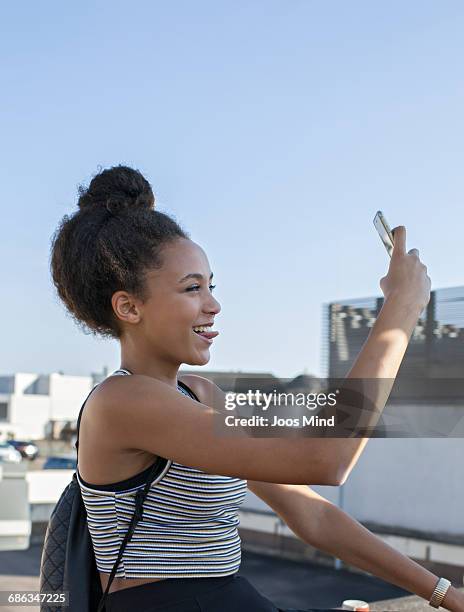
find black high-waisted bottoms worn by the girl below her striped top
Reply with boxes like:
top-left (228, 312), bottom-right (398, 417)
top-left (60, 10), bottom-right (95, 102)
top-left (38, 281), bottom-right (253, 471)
top-left (106, 574), bottom-right (326, 612)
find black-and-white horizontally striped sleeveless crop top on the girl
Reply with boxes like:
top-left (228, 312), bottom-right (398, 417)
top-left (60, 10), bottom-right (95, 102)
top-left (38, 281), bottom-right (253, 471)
top-left (76, 370), bottom-right (247, 578)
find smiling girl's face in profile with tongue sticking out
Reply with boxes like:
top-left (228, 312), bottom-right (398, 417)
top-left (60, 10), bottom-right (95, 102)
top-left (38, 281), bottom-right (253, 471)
top-left (136, 238), bottom-right (221, 365)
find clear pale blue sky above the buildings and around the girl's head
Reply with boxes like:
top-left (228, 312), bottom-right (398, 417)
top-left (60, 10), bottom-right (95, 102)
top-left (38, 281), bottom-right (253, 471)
top-left (0, 0), bottom-right (464, 376)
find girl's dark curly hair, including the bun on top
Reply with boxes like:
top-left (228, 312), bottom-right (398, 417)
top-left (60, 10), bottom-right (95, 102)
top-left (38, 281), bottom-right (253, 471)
top-left (50, 165), bottom-right (189, 338)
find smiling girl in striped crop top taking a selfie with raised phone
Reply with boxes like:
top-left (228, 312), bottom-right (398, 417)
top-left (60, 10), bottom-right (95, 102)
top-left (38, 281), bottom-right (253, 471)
top-left (51, 166), bottom-right (464, 612)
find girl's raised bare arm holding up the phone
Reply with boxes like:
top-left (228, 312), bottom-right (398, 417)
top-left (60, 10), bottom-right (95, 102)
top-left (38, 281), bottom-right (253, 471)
top-left (92, 228), bottom-right (430, 485)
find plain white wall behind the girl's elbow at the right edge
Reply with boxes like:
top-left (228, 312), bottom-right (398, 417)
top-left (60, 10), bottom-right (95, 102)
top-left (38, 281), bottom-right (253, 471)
top-left (244, 438), bottom-right (464, 539)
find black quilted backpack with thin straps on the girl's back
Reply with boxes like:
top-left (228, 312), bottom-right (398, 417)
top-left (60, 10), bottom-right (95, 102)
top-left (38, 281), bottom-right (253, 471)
top-left (40, 383), bottom-right (172, 612)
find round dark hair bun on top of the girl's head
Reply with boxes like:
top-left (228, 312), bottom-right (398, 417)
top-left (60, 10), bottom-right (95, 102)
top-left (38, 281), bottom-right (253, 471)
top-left (78, 166), bottom-right (155, 214)
